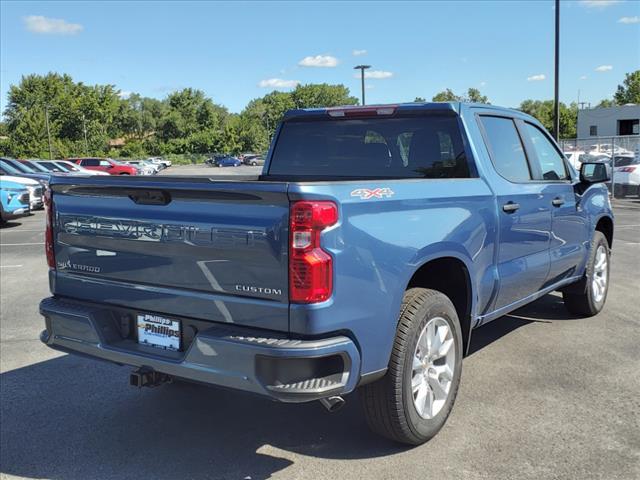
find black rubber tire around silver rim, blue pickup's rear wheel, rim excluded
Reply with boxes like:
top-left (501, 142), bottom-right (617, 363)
top-left (360, 288), bottom-right (463, 445)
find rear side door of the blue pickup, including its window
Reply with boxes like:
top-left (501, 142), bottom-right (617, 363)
top-left (478, 111), bottom-right (551, 310)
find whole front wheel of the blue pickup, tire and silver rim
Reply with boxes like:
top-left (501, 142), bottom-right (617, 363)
top-left (562, 231), bottom-right (610, 317)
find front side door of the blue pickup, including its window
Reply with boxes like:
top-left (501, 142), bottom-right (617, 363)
top-left (517, 121), bottom-right (590, 285)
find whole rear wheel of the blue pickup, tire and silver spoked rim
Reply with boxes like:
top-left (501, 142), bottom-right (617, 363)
top-left (361, 288), bottom-right (462, 445)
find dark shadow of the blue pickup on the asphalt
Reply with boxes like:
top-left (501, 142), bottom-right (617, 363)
top-left (0, 296), bottom-right (580, 480)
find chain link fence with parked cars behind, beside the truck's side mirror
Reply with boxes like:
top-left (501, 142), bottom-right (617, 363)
top-left (559, 135), bottom-right (640, 199)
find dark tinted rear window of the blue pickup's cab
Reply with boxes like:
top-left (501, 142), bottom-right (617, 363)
top-left (269, 116), bottom-right (471, 178)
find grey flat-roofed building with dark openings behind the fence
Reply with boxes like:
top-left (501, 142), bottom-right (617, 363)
top-left (578, 105), bottom-right (640, 138)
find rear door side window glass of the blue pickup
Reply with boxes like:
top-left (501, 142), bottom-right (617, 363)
top-left (480, 116), bottom-right (531, 182)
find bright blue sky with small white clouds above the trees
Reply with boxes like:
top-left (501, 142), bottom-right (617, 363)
top-left (0, 0), bottom-right (640, 112)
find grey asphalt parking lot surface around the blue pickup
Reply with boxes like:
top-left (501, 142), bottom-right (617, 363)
top-left (0, 171), bottom-right (640, 480)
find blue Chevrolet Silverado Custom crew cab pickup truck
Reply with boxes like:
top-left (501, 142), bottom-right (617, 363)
top-left (40, 103), bottom-right (613, 444)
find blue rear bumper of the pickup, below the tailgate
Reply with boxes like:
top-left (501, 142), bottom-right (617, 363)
top-left (40, 297), bottom-right (360, 402)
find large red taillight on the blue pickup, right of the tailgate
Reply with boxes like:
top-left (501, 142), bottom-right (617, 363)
top-left (289, 200), bottom-right (338, 303)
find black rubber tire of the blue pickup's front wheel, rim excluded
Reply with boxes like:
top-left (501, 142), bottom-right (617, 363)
top-left (562, 231), bottom-right (611, 317)
